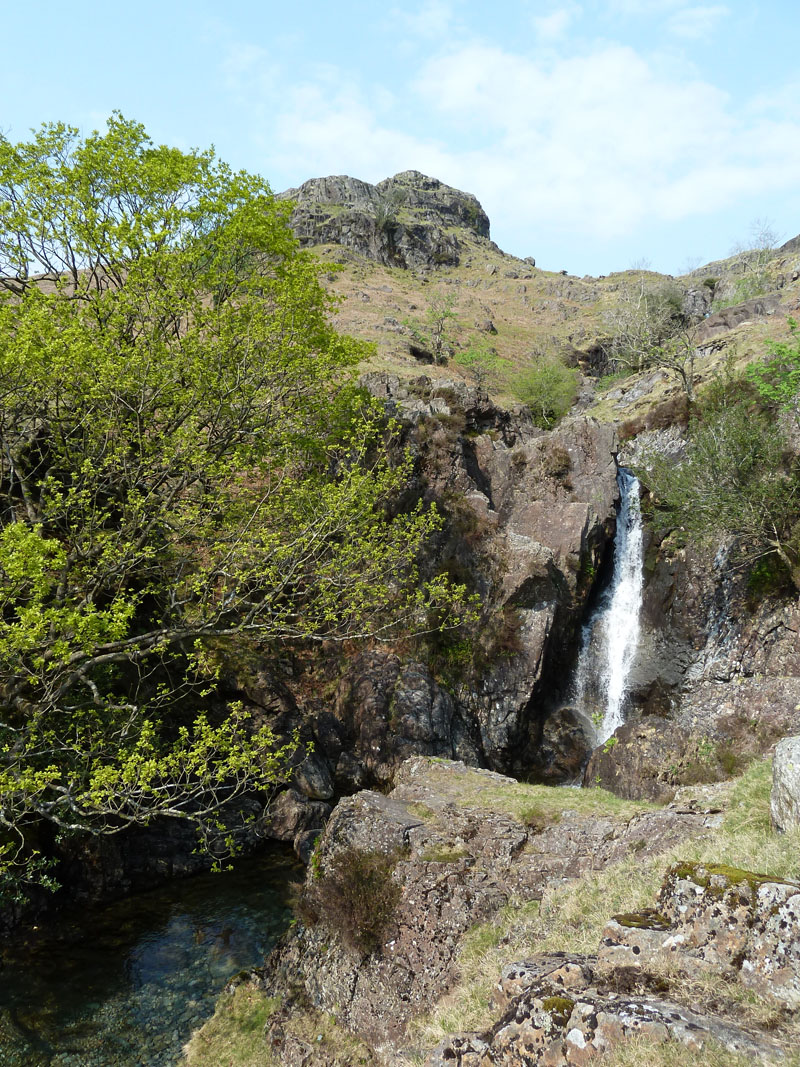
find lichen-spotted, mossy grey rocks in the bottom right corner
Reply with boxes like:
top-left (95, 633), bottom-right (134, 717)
top-left (426, 863), bottom-right (800, 1067)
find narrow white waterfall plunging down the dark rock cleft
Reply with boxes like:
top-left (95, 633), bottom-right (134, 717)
top-left (571, 467), bottom-right (643, 745)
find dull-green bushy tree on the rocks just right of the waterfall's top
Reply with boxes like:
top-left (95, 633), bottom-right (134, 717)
top-left (641, 362), bottom-right (800, 588)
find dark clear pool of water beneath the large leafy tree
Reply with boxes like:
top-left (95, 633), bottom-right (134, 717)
top-left (0, 850), bottom-right (303, 1067)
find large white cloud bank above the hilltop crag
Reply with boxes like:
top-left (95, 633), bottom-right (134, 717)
top-left (213, 19), bottom-right (800, 264)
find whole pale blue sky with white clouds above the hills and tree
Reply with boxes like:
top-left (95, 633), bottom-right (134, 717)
top-left (0, 0), bottom-right (800, 274)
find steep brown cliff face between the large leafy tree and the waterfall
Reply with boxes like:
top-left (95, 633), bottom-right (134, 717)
top-left (241, 373), bottom-right (618, 856)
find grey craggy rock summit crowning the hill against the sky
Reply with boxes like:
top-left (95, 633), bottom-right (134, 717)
top-left (278, 171), bottom-right (489, 269)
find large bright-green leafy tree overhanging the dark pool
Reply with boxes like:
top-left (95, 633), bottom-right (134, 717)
top-left (0, 114), bottom-right (469, 885)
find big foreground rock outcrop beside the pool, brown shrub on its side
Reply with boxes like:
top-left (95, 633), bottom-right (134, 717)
top-left (258, 758), bottom-right (710, 1046)
